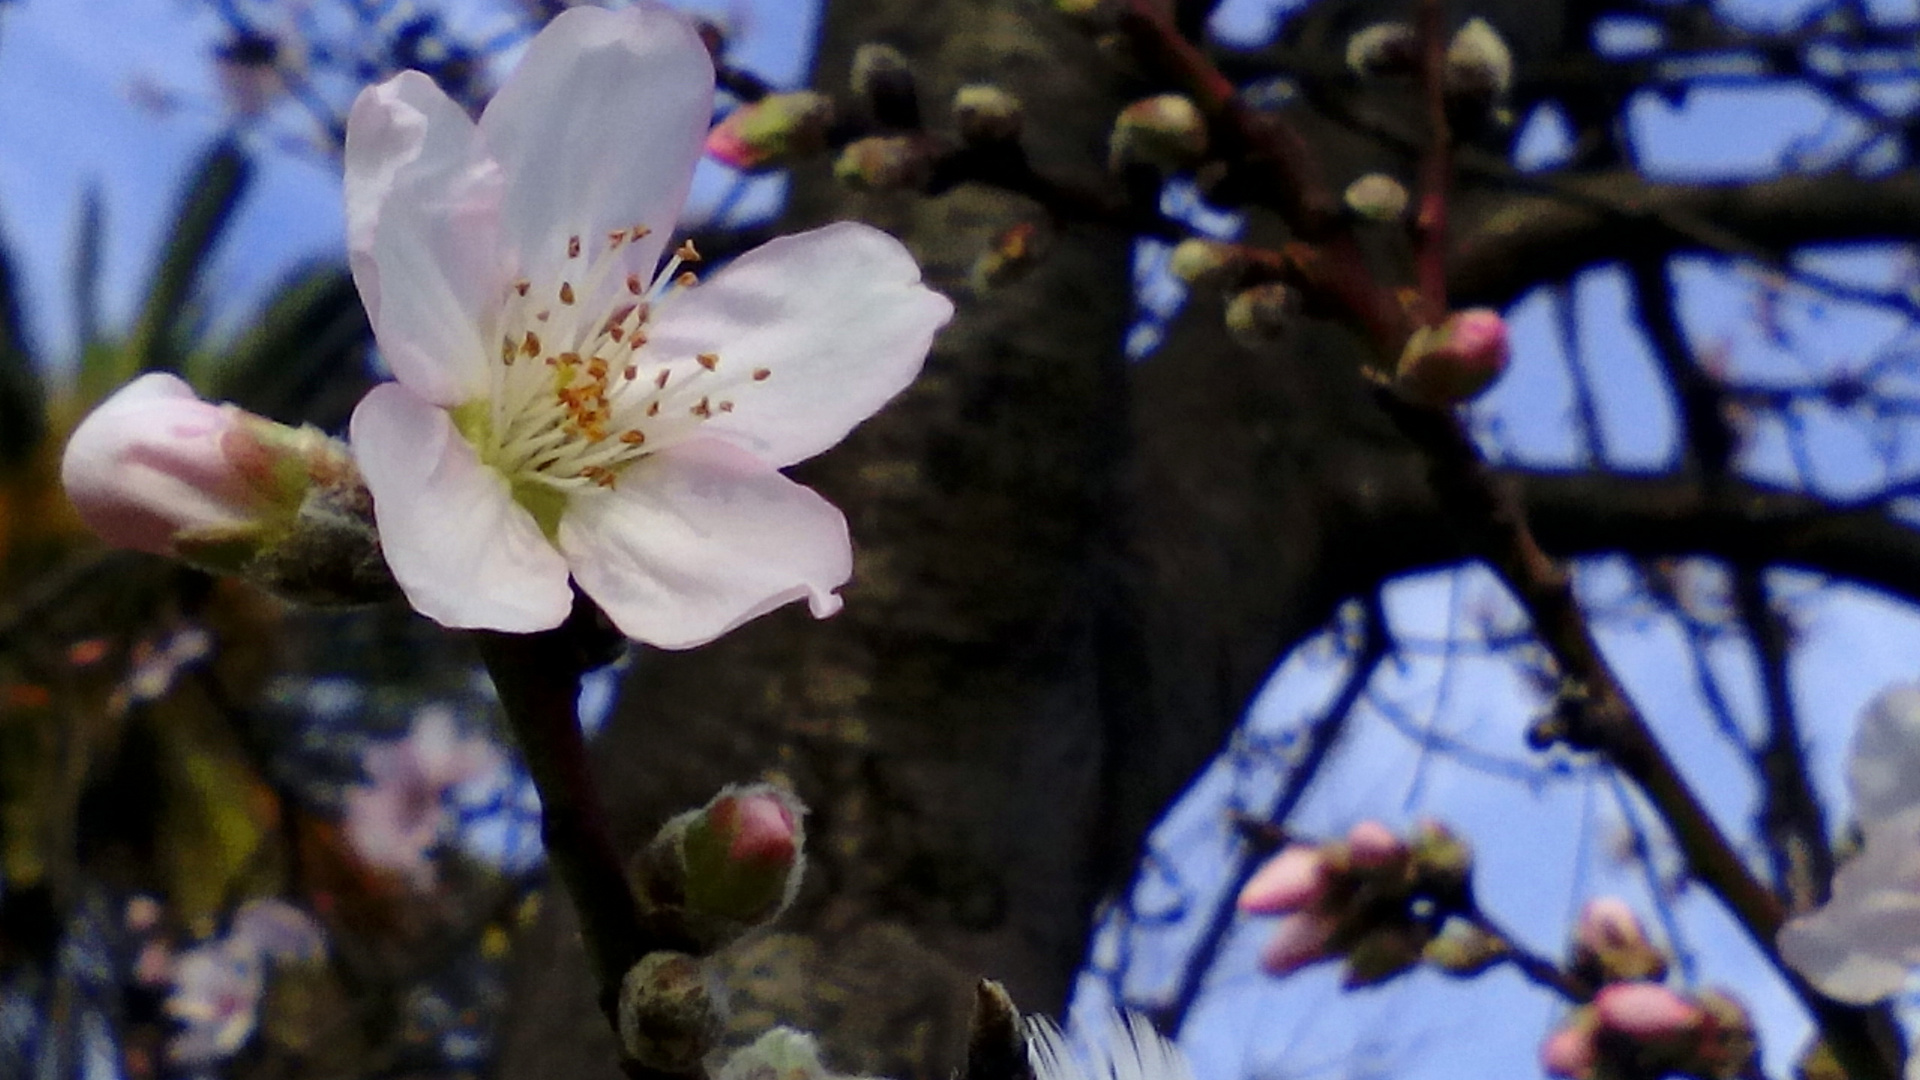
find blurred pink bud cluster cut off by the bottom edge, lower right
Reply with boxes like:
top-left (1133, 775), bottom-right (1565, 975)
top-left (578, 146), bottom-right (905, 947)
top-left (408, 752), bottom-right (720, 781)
top-left (1540, 982), bottom-right (1757, 1080)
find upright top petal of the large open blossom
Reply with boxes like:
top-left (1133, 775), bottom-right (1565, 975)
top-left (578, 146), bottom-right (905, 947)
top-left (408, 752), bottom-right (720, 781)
top-left (480, 0), bottom-right (714, 281)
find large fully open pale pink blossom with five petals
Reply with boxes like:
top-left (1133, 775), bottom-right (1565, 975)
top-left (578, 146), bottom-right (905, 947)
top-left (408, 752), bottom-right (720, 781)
top-left (346, 2), bottom-right (952, 648)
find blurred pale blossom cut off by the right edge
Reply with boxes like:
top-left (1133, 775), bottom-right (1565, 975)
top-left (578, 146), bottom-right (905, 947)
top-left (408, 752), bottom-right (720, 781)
top-left (1778, 686), bottom-right (1920, 1005)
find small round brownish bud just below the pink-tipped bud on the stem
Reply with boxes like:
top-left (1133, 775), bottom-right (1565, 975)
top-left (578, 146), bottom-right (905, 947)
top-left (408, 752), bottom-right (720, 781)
top-left (618, 951), bottom-right (726, 1072)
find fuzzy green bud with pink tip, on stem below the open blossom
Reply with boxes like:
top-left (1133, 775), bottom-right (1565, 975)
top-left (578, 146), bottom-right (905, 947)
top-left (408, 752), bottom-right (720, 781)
top-left (630, 784), bottom-right (806, 953)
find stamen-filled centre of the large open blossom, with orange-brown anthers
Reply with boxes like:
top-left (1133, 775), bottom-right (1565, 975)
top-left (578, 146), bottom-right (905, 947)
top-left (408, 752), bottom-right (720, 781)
top-left (455, 225), bottom-right (772, 532)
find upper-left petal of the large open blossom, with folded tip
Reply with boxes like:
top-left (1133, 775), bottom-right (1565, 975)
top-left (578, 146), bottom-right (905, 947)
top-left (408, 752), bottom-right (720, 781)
top-left (346, 71), bottom-right (509, 405)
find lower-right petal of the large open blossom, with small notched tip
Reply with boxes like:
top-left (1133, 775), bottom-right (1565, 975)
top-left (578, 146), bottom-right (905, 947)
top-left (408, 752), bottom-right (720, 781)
top-left (559, 440), bottom-right (852, 650)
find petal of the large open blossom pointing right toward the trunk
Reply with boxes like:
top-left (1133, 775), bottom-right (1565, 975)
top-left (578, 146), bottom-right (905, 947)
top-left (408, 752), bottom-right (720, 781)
top-left (647, 221), bottom-right (952, 465)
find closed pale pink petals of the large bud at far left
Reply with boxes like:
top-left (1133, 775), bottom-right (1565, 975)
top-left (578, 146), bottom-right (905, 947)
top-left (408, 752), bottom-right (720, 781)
top-left (60, 373), bottom-right (265, 555)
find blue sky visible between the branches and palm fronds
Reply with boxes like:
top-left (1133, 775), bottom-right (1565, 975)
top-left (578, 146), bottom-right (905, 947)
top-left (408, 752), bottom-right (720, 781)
top-left (0, 0), bottom-right (1920, 1080)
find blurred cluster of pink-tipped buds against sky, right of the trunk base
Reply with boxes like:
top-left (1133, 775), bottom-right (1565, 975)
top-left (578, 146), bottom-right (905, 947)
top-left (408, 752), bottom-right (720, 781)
top-left (1240, 821), bottom-right (1474, 988)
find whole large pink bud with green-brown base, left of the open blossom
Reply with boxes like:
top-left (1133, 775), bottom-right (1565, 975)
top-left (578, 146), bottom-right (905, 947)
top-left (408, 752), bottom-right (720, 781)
top-left (60, 373), bottom-right (394, 603)
